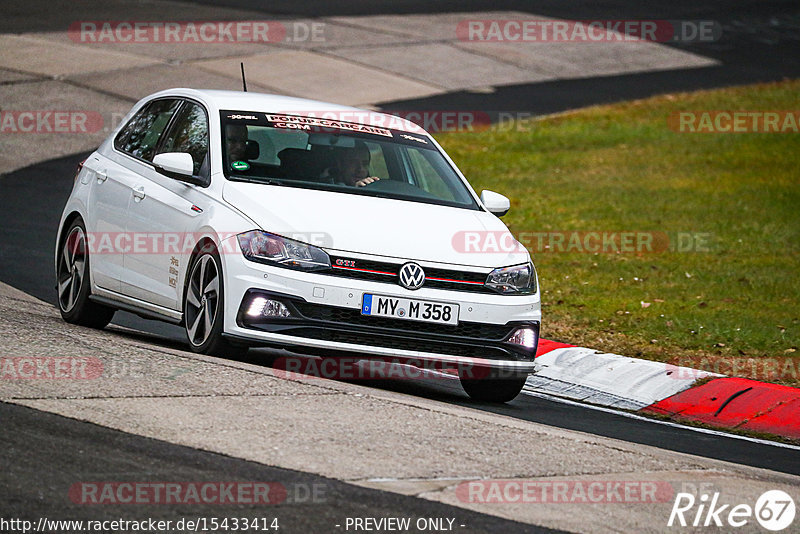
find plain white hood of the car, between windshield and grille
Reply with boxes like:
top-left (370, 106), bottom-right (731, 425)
top-left (223, 181), bottom-right (528, 268)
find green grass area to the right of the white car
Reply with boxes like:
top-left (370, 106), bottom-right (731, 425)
top-left (439, 81), bottom-right (800, 385)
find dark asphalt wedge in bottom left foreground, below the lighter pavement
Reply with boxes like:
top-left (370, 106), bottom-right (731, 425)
top-left (0, 403), bottom-right (554, 534)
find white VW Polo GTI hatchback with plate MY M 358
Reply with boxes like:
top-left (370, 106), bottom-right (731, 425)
top-left (55, 89), bottom-right (541, 402)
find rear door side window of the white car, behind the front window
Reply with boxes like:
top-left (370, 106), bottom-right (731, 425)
top-left (114, 99), bottom-right (180, 161)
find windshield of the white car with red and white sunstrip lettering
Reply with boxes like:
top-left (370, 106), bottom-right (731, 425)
top-left (220, 111), bottom-right (479, 209)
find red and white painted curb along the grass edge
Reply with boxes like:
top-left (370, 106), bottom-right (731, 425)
top-left (523, 339), bottom-right (800, 439)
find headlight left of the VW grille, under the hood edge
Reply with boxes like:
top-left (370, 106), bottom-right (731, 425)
top-left (236, 230), bottom-right (331, 271)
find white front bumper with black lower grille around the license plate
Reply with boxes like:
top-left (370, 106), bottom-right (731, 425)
top-left (225, 254), bottom-right (541, 373)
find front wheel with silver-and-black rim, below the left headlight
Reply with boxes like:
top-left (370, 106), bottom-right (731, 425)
top-left (183, 247), bottom-right (247, 357)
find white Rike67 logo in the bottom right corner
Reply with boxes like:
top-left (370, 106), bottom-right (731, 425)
top-left (667, 490), bottom-right (796, 532)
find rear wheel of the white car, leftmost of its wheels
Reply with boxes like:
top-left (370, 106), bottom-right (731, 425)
top-left (56, 217), bottom-right (116, 328)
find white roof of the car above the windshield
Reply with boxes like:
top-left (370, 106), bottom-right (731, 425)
top-left (144, 88), bottom-right (427, 134)
